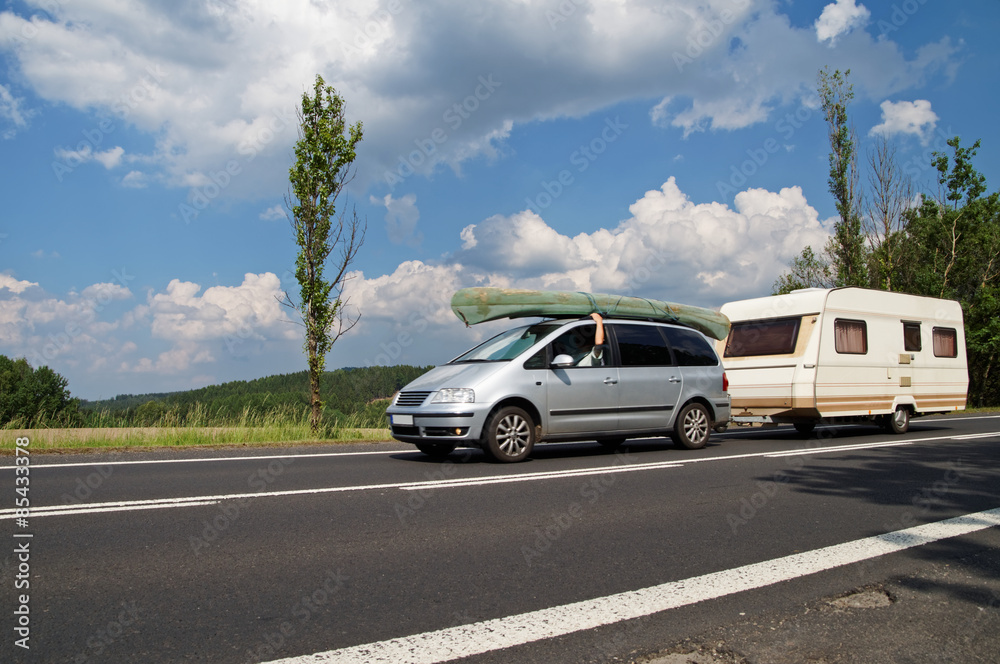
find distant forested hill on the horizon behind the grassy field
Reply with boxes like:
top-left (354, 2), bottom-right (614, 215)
top-left (80, 365), bottom-right (431, 424)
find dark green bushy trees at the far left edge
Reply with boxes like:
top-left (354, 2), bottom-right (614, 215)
top-left (0, 355), bottom-right (80, 428)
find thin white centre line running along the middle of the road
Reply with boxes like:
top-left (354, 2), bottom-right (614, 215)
top-left (0, 432), bottom-right (998, 520)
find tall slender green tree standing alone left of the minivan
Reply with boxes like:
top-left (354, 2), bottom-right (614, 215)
top-left (285, 75), bottom-right (367, 434)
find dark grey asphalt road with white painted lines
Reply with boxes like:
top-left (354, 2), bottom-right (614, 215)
top-left (0, 415), bottom-right (1000, 663)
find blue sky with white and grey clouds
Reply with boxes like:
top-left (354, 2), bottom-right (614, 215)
top-left (0, 0), bottom-right (1000, 400)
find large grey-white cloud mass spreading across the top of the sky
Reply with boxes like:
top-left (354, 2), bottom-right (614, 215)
top-left (0, 0), bottom-right (954, 197)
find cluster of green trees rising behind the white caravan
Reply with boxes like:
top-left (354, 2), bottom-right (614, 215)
top-left (773, 69), bottom-right (1000, 406)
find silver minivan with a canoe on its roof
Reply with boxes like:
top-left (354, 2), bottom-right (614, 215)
top-left (386, 318), bottom-right (730, 462)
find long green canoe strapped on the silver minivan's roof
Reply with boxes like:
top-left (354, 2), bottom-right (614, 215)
top-left (451, 288), bottom-right (729, 339)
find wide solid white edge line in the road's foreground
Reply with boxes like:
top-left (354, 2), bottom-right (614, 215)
top-left (270, 508), bottom-right (1000, 664)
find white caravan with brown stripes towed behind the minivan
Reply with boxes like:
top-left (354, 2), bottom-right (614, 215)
top-left (718, 288), bottom-right (969, 433)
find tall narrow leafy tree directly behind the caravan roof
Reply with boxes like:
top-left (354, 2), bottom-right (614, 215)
top-left (818, 67), bottom-right (868, 286)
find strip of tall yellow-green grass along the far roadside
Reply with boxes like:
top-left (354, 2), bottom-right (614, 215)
top-left (0, 424), bottom-right (390, 455)
